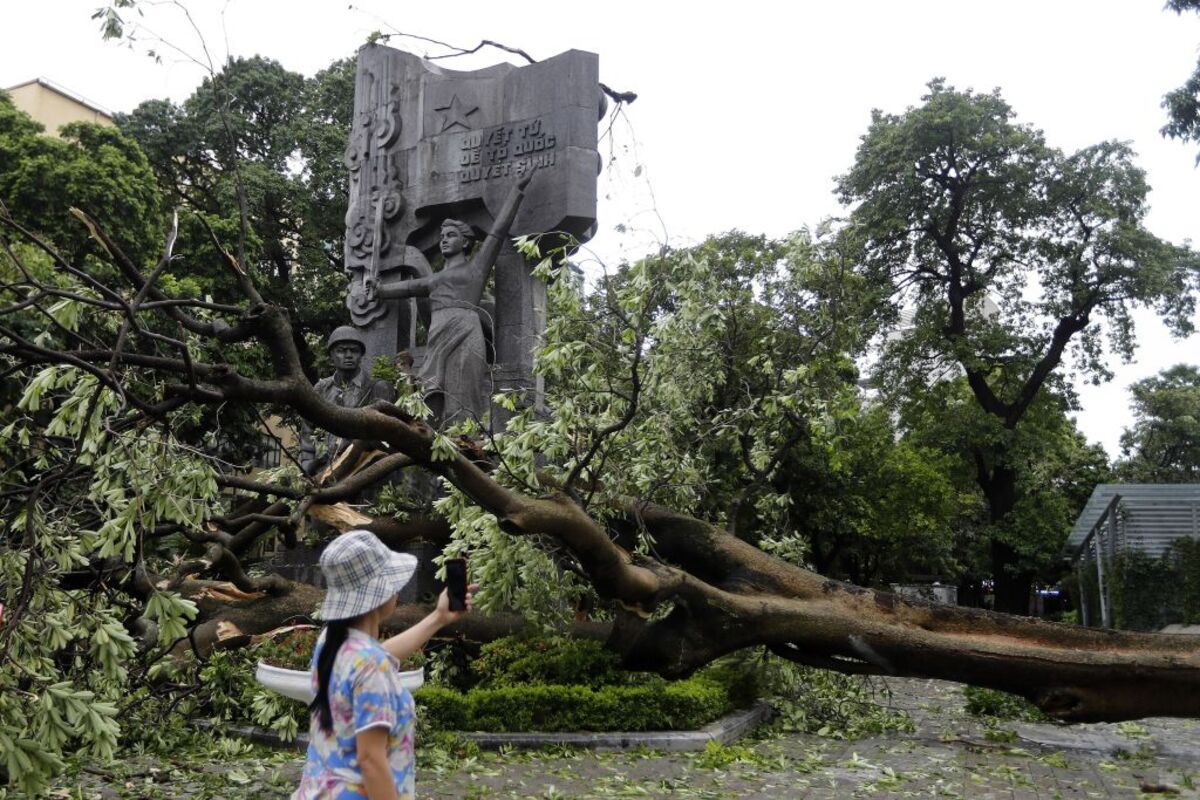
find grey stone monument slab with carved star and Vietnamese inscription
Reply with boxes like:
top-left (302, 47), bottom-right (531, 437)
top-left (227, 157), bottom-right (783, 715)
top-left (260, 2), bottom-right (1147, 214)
top-left (346, 44), bottom-right (604, 427)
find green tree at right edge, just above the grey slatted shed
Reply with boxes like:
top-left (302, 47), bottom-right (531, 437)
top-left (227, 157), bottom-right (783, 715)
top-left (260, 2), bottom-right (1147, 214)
top-left (1116, 363), bottom-right (1200, 483)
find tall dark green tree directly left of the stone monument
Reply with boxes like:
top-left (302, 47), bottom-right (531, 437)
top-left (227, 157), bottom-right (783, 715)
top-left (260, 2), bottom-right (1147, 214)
top-left (116, 56), bottom-right (354, 357)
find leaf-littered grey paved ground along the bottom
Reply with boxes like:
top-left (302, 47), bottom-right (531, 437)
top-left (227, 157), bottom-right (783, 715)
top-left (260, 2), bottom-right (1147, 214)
top-left (58, 680), bottom-right (1200, 800)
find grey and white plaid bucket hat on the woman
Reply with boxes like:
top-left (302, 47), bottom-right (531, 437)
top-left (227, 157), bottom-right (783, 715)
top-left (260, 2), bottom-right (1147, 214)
top-left (320, 530), bottom-right (416, 622)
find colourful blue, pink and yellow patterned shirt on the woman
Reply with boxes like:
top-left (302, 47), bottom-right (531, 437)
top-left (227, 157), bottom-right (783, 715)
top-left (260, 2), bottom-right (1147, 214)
top-left (292, 627), bottom-right (416, 800)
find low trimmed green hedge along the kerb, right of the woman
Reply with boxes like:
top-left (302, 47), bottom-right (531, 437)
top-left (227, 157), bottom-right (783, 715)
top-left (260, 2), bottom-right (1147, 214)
top-left (415, 678), bottom-right (733, 733)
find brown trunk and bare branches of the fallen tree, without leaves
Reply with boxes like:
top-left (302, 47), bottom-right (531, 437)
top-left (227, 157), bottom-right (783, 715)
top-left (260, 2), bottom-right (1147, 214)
top-left (0, 211), bottom-right (1200, 721)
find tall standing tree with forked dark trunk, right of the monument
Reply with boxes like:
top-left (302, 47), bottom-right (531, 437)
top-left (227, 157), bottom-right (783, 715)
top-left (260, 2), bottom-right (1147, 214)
top-left (839, 80), bottom-right (1196, 613)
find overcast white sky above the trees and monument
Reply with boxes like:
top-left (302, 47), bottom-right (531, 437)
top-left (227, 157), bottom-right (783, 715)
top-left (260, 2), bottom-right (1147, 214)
top-left (0, 0), bottom-right (1200, 456)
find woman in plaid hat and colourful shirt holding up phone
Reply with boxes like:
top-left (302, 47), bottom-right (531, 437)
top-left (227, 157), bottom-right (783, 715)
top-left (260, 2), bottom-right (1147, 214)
top-left (292, 530), bottom-right (475, 800)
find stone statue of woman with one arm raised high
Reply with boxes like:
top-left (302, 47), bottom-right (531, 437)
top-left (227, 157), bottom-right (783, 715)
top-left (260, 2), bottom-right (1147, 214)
top-left (367, 176), bottom-right (532, 425)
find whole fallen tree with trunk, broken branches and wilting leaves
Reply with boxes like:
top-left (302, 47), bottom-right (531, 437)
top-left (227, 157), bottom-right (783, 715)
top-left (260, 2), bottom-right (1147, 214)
top-left (0, 203), bottom-right (1200, 743)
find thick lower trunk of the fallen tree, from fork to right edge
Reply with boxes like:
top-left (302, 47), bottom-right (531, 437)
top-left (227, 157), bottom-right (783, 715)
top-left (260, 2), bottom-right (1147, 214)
top-left (600, 506), bottom-right (1200, 721)
